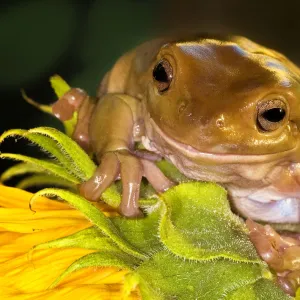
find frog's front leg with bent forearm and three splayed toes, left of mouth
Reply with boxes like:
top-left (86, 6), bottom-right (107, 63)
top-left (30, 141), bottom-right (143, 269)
top-left (80, 94), bottom-right (173, 217)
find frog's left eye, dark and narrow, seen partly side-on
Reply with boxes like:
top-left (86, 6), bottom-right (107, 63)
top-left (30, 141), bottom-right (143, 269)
top-left (153, 59), bottom-right (173, 93)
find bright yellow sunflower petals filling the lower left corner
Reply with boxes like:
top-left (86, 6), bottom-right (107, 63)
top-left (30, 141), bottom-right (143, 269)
top-left (0, 185), bottom-right (140, 299)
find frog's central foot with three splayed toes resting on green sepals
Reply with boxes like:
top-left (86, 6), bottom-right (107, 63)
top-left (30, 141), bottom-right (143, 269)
top-left (79, 151), bottom-right (174, 217)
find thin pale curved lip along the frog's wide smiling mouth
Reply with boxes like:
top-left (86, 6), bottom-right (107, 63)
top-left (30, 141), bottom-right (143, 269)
top-left (149, 118), bottom-right (299, 164)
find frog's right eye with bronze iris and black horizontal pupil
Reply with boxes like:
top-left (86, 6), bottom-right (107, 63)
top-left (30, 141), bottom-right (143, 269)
top-left (257, 99), bottom-right (287, 131)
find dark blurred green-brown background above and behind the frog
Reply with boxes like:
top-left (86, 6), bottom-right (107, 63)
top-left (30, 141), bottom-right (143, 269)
top-left (0, 0), bottom-right (300, 171)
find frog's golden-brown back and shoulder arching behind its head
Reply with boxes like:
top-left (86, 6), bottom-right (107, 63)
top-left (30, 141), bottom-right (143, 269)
top-left (97, 34), bottom-right (299, 98)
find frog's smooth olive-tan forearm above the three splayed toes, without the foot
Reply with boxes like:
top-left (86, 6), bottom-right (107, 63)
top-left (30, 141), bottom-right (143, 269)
top-left (90, 94), bottom-right (138, 159)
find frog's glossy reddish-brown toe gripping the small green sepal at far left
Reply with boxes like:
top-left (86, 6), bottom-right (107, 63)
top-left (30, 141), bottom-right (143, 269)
top-left (52, 88), bottom-right (87, 121)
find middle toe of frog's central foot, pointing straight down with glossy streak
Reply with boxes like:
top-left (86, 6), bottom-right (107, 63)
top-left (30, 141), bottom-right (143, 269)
top-left (117, 153), bottom-right (143, 218)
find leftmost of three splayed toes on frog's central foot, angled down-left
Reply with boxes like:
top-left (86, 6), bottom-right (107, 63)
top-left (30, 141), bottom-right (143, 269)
top-left (79, 152), bottom-right (120, 201)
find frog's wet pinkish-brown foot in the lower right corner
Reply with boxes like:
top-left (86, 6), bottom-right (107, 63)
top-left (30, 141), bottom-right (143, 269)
top-left (246, 219), bottom-right (300, 296)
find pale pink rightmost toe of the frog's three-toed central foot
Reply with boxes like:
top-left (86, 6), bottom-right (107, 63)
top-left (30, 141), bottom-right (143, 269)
top-left (141, 159), bottom-right (175, 193)
